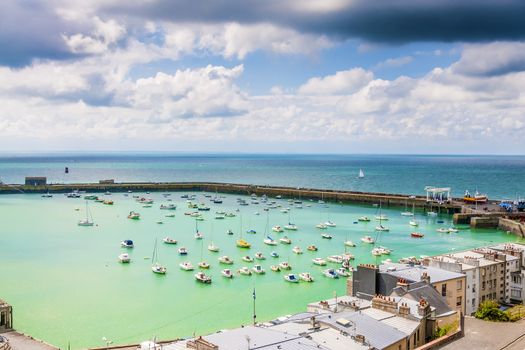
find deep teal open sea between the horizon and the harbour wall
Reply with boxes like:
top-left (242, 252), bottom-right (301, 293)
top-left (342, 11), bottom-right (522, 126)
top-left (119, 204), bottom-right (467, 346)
top-left (0, 153), bottom-right (525, 199)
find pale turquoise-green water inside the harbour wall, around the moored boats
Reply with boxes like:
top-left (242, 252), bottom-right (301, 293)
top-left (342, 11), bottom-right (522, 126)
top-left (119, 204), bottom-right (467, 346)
top-left (0, 193), bottom-right (516, 349)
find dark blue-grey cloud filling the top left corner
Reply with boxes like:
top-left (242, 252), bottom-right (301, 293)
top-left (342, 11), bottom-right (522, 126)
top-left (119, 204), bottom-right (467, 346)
top-left (0, 0), bottom-right (80, 67)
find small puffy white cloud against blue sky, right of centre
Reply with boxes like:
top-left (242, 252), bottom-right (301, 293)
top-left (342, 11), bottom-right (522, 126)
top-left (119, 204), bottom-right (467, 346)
top-left (298, 68), bottom-right (374, 95)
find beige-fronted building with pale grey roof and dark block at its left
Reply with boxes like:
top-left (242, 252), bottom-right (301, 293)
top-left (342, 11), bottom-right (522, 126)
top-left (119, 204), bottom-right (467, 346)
top-left (349, 263), bottom-right (466, 313)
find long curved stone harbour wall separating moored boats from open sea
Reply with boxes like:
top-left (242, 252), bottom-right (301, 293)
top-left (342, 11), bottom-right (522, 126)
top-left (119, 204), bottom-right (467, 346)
top-left (0, 182), bottom-right (461, 214)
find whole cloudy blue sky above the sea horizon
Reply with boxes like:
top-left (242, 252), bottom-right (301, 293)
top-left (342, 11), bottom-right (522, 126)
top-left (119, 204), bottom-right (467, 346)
top-left (0, 0), bottom-right (525, 154)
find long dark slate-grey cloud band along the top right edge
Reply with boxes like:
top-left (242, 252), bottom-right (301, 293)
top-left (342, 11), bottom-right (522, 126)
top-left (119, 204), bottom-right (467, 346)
top-left (106, 0), bottom-right (525, 43)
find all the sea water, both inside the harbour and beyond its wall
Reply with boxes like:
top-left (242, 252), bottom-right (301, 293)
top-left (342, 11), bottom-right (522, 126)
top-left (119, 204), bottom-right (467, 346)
top-left (0, 154), bottom-right (525, 349)
